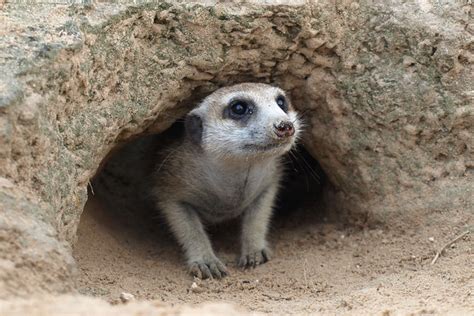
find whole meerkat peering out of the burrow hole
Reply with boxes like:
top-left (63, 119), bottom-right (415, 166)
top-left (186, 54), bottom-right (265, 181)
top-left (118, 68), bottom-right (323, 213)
top-left (152, 83), bottom-right (301, 278)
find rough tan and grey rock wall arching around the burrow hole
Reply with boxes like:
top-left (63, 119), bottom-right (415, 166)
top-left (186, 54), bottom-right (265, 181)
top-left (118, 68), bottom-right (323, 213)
top-left (0, 0), bottom-right (474, 311)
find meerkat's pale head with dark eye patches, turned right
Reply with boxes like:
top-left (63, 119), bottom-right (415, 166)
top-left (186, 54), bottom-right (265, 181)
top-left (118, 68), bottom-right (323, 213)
top-left (185, 83), bottom-right (301, 160)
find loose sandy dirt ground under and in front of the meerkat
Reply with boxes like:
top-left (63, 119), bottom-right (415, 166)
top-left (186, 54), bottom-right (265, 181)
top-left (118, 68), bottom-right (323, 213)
top-left (74, 183), bottom-right (474, 315)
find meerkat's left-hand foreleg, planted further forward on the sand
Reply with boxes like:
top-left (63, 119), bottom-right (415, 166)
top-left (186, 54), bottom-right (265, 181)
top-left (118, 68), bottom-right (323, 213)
top-left (162, 203), bottom-right (227, 279)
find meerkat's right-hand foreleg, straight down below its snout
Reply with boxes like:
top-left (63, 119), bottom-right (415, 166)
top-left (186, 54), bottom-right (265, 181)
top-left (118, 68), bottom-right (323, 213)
top-left (239, 185), bottom-right (277, 268)
